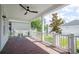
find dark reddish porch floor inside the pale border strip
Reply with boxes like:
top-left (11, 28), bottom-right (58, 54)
top-left (1, 37), bottom-right (48, 54)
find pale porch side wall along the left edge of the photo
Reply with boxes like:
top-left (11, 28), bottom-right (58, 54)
top-left (0, 5), bottom-right (9, 51)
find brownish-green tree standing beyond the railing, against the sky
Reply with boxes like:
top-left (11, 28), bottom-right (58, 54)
top-left (49, 13), bottom-right (64, 34)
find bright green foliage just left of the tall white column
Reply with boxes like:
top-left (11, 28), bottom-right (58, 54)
top-left (31, 18), bottom-right (42, 31)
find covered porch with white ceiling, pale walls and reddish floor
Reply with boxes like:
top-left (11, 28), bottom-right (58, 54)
top-left (0, 4), bottom-right (73, 54)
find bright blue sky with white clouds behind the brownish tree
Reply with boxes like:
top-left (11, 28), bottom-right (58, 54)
top-left (45, 5), bottom-right (79, 24)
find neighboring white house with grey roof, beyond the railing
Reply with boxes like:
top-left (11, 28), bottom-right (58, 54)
top-left (62, 20), bottom-right (79, 36)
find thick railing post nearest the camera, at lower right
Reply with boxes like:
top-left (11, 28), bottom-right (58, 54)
top-left (68, 34), bottom-right (76, 54)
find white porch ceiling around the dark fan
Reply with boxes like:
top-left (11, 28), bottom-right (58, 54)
top-left (2, 4), bottom-right (64, 21)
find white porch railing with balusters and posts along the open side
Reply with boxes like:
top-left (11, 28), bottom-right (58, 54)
top-left (31, 31), bottom-right (79, 53)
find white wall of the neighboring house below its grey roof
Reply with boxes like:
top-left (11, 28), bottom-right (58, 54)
top-left (62, 25), bottom-right (79, 35)
